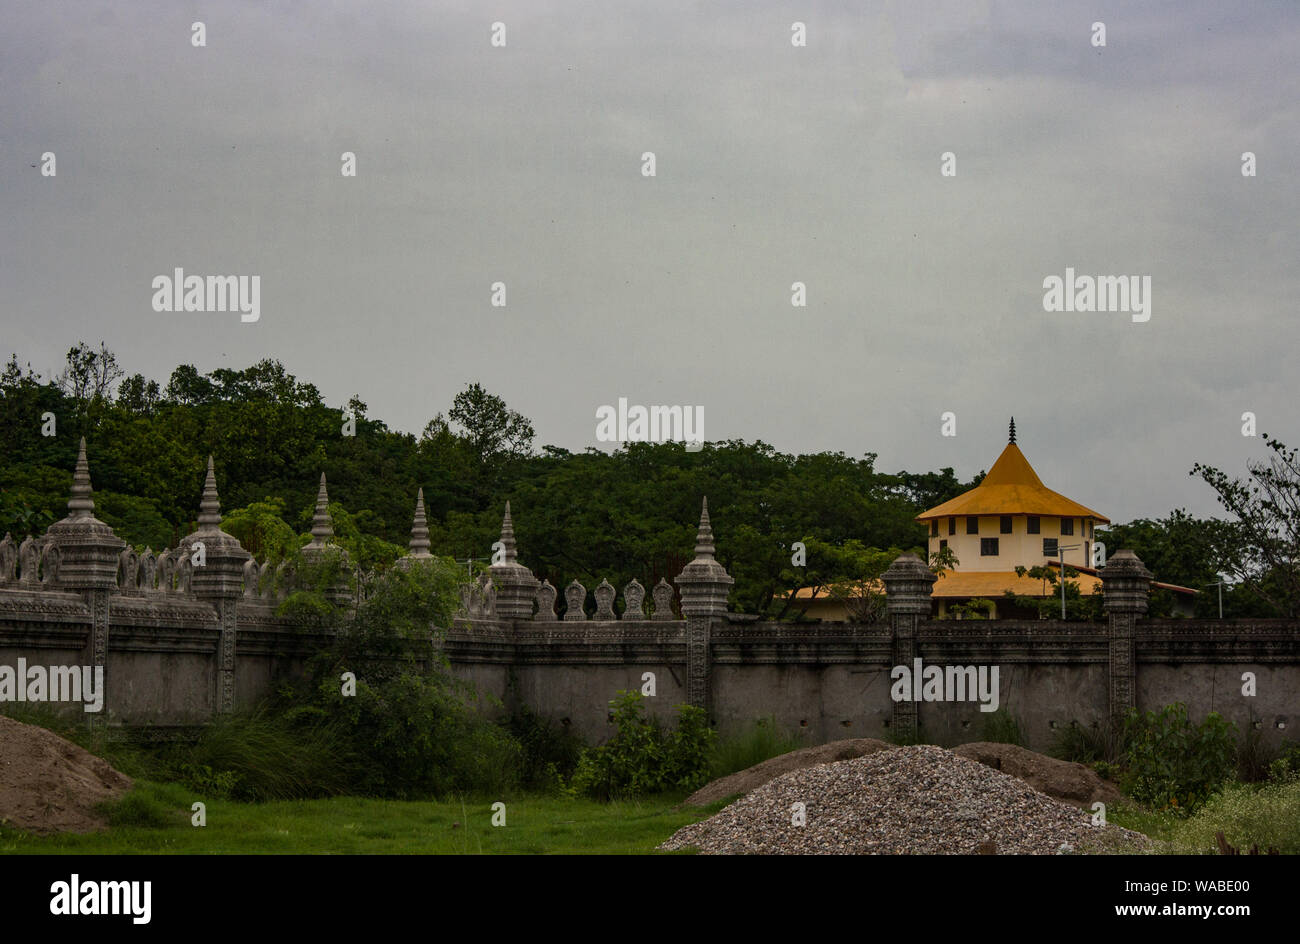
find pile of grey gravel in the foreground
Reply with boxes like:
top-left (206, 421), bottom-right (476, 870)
top-left (659, 746), bottom-right (1149, 856)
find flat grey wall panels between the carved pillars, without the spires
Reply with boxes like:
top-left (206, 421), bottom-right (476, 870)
top-left (0, 588), bottom-right (1300, 749)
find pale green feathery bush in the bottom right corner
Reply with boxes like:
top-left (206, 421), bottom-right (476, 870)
top-left (1171, 780), bottom-right (1300, 856)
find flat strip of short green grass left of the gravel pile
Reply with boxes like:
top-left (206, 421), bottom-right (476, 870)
top-left (0, 781), bottom-right (723, 856)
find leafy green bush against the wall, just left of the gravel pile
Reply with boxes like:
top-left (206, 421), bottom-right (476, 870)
top-left (569, 692), bottom-right (716, 800)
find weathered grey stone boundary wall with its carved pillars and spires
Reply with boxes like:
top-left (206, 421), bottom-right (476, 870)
top-left (0, 447), bottom-right (1300, 749)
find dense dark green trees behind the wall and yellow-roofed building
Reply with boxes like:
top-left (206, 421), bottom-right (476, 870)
top-left (0, 343), bottom-right (1300, 619)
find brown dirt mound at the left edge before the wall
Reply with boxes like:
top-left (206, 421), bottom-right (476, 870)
top-left (0, 715), bottom-right (131, 833)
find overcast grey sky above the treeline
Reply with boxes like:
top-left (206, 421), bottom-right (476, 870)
top-left (0, 0), bottom-right (1300, 521)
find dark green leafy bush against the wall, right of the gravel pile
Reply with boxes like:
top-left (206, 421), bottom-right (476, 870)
top-left (1123, 702), bottom-right (1236, 814)
